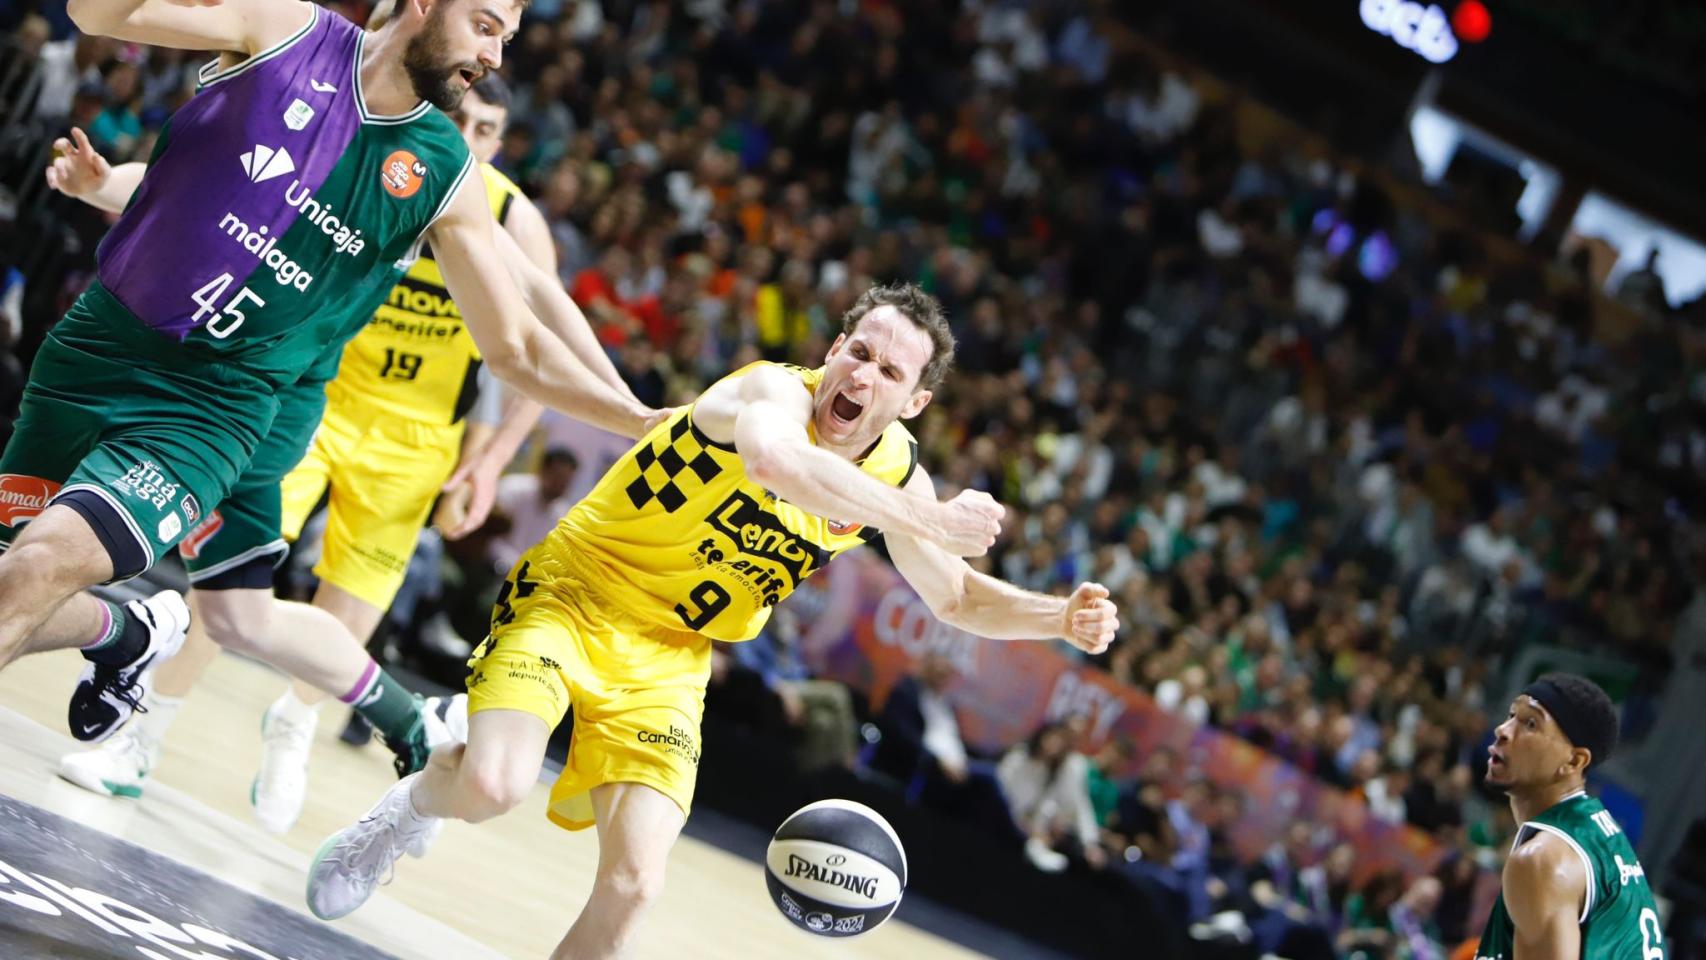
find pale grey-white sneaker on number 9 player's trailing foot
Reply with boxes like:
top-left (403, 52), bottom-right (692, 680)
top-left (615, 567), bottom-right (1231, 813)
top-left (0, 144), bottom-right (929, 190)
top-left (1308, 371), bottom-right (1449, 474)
top-left (307, 774), bottom-right (437, 921)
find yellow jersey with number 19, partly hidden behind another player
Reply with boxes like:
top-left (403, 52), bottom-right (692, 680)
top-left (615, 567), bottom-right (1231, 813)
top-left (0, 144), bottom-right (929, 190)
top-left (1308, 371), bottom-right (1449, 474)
top-left (329, 164), bottom-right (525, 425)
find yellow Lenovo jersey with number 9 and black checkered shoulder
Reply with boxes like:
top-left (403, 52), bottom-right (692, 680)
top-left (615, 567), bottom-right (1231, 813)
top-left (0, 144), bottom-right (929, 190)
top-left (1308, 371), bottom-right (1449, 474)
top-left (546, 361), bottom-right (918, 641)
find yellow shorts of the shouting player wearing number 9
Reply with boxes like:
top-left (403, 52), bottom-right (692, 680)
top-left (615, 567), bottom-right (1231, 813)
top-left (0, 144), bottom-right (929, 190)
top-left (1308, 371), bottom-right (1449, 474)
top-left (467, 534), bottom-right (711, 830)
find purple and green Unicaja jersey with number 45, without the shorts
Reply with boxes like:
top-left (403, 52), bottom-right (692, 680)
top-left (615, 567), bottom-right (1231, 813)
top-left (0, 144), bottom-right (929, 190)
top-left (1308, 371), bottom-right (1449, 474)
top-left (96, 7), bottom-right (474, 385)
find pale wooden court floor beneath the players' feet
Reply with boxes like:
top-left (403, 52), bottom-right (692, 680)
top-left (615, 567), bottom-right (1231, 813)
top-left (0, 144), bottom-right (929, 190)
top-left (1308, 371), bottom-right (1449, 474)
top-left (0, 651), bottom-right (978, 960)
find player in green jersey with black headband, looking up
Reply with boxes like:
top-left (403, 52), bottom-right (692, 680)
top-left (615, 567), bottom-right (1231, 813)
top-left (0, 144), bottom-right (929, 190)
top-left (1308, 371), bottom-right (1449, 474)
top-left (1476, 674), bottom-right (1665, 960)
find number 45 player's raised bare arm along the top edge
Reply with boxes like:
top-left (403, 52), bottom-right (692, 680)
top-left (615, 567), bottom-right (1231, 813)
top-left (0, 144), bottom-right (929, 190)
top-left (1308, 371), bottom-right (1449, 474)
top-left (65, 0), bottom-right (310, 56)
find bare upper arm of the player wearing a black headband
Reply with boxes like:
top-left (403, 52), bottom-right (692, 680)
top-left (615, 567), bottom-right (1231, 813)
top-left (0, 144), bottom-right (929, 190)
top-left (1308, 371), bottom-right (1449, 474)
top-left (1503, 834), bottom-right (1587, 960)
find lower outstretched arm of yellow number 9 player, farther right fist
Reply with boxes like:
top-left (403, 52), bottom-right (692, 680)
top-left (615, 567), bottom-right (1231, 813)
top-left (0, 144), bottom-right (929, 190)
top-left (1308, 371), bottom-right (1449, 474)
top-left (884, 469), bottom-right (1119, 653)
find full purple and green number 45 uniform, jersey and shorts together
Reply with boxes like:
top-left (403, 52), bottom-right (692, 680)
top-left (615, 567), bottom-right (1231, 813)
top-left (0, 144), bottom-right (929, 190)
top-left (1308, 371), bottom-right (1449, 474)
top-left (0, 5), bottom-right (474, 578)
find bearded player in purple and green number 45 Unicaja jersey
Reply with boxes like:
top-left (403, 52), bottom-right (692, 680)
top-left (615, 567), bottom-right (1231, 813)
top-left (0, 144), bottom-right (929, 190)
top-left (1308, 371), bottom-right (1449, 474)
top-left (0, 0), bottom-right (659, 740)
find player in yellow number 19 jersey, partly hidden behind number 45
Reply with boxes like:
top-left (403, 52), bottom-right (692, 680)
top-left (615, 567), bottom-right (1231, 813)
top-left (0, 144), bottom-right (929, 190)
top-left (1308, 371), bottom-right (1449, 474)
top-left (60, 75), bottom-right (628, 832)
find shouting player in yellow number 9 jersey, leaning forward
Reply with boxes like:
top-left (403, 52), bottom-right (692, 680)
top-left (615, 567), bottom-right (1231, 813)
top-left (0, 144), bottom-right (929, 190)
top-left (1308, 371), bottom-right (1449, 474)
top-left (309, 286), bottom-right (1117, 960)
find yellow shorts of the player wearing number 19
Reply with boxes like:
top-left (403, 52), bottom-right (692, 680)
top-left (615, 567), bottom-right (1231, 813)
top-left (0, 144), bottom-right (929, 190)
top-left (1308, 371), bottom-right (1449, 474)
top-left (280, 390), bottom-right (462, 610)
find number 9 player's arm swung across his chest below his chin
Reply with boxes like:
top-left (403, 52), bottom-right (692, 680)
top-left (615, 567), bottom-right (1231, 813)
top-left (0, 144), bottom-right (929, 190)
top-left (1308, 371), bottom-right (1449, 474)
top-left (693, 367), bottom-right (1003, 556)
